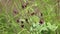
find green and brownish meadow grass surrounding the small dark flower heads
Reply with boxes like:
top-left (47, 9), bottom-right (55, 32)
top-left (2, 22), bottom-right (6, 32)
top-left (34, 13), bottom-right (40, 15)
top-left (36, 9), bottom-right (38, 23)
top-left (0, 0), bottom-right (60, 34)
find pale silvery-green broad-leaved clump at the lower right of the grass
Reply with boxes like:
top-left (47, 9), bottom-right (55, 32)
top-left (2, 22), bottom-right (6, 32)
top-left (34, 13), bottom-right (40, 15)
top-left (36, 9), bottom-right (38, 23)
top-left (30, 22), bottom-right (58, 34)
